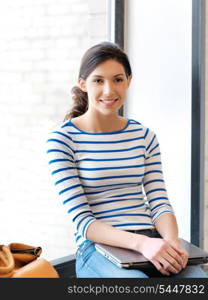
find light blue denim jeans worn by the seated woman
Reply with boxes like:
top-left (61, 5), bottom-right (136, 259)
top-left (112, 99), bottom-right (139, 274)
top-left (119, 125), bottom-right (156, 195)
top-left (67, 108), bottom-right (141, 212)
top-left (76, 230), bottom-right (208, 278)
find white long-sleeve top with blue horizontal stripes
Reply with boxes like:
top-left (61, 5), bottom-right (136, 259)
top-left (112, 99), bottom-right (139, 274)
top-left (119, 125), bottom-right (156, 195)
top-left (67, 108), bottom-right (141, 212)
top-left (46, 119), bottom-right (174, 247)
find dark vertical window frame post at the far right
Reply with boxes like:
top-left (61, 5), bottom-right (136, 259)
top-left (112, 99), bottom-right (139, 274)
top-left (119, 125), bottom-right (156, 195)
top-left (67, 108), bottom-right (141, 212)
top-left (191, 0), bottom-right (205, 247)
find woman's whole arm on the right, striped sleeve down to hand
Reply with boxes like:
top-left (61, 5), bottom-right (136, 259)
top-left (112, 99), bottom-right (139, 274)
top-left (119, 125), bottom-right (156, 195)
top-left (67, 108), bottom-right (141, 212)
top-left (143, 129), bottom-right (188, 267)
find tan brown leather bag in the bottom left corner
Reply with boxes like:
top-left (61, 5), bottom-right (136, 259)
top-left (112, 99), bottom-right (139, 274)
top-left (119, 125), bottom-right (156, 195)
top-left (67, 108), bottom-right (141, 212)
top-left (0, 243), bottom-right (59, 278)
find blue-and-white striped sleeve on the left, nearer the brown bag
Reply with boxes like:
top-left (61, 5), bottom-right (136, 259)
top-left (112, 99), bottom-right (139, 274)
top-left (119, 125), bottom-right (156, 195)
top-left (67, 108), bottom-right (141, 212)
top-left (46, 129), bottom-right (95, 238)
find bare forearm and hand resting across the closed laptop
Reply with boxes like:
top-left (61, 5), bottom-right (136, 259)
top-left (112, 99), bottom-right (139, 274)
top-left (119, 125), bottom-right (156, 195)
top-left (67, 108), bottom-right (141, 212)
top-left (86, 220), bottom-right (185, 275)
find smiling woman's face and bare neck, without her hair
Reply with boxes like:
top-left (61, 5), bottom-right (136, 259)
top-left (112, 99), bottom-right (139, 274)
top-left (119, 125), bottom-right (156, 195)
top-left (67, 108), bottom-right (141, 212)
top-left (73, 59), bottom-right (131, 132)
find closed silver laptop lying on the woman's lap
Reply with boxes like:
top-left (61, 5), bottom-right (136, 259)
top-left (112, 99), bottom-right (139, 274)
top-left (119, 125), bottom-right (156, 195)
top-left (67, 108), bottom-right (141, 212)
top-left (95, 239), bottom-right (208, 269)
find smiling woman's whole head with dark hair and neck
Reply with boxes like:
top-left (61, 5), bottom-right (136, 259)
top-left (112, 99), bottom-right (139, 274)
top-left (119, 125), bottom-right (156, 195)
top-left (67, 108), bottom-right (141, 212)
top-left (65, 42), bottom-right (132, 132)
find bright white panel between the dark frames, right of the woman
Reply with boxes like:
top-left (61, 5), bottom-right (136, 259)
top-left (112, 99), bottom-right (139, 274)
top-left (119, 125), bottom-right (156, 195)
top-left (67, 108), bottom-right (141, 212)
top-left (124, 0), bottom-right (192, 240)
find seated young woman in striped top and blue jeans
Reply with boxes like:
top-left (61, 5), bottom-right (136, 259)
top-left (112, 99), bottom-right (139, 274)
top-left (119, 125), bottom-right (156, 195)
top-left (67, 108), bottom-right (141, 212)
top-left (47, 42), bottom-right (205, 278)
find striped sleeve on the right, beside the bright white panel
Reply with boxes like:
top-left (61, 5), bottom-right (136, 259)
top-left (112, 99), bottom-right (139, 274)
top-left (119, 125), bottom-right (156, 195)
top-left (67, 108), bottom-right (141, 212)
top-left (143, 128), bottom-right (174, 223)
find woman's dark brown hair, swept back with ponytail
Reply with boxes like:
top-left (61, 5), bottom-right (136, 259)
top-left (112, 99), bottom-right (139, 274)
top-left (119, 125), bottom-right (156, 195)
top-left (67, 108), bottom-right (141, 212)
top-left (64, 42), bottom-right (132, 121)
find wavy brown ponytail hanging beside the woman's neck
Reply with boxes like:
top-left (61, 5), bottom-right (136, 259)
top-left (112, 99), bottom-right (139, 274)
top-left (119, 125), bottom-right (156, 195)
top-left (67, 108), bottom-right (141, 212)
top-left (64, 86), bottom-right (88, 122)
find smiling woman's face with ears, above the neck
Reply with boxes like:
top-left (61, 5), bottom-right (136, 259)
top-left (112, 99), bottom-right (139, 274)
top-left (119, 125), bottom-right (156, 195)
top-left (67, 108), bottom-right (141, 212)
top-left (79, 59), bottom-right (131, 115)
